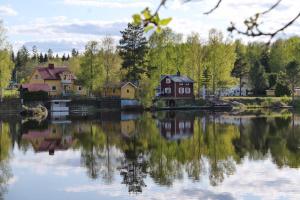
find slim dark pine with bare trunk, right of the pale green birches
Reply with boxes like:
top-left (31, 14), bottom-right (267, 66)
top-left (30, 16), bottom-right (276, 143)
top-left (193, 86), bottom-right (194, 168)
top-left (231, 40), bottom-right (249, 96)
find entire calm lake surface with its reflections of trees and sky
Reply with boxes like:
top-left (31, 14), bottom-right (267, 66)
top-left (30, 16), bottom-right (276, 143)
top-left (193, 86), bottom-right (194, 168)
top-left (0, 112), bottom-right (300, 200)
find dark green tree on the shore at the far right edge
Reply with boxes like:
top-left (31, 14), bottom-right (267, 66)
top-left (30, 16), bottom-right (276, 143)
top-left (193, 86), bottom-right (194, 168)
top-left (286, 61), bottom-right (300, 106)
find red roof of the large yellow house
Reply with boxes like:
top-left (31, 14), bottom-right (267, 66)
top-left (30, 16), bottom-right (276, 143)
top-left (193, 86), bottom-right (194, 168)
top-left (37, 66), bottom-right (75, 80)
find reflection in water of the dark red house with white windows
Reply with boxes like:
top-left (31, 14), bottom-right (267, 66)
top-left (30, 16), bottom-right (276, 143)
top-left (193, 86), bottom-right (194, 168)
top-left (158, 112), bottom-right (194, 140)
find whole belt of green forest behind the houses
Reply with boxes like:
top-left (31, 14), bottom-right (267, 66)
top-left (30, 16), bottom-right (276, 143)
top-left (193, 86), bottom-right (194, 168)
top-left (0, 23), bottom-right (300, 105)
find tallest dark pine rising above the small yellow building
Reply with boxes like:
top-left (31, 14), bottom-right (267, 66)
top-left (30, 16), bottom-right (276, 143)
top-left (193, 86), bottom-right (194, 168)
top-left (118, 23), bottom-right (148, 82)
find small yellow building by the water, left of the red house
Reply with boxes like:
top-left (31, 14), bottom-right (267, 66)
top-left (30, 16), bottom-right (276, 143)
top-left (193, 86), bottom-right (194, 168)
top-left (103, 82), bottom-right (137, 99)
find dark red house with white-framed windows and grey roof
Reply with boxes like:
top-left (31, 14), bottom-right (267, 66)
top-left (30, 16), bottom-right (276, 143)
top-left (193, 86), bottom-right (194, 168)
top-left (159, 72), bottom-right (194, 99)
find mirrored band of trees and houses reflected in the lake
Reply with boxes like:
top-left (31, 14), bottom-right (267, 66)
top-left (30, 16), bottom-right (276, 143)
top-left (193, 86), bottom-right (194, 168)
top-left (0, 112), bottom-right (300, 198)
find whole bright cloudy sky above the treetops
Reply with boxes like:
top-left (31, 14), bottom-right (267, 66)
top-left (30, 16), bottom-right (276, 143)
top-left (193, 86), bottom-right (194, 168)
top-left (0, 0), bottom-right (300, 53)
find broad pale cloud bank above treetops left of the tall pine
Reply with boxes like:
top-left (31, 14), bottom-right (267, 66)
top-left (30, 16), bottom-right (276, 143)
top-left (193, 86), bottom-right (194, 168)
top-left (8, 16), bottom-right (127, 54)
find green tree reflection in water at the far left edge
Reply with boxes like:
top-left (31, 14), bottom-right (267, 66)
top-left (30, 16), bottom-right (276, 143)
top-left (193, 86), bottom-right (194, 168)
top-left (0, 121), bottom-right (12, 199)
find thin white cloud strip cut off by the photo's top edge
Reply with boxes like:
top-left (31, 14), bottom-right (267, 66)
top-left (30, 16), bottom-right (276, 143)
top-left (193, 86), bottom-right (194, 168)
top-left (63, 0), bottom-right (152, 8)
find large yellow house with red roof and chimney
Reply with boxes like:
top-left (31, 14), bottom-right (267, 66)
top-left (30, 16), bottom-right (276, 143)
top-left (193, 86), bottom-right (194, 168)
top-left (21, 64), bottom-right (86, 96)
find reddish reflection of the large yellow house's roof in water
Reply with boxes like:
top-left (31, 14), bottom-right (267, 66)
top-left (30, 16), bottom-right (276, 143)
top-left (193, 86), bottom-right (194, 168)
top-left (22, 129), bottom-right (73, 155)
